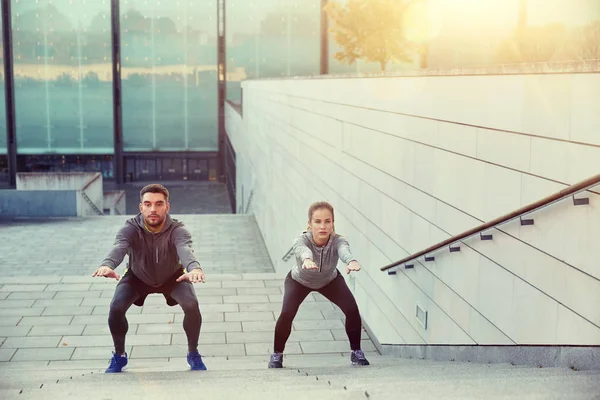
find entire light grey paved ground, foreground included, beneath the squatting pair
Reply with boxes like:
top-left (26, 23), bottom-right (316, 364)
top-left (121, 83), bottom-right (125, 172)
top-left (0, 215), bottom-right (600, 400)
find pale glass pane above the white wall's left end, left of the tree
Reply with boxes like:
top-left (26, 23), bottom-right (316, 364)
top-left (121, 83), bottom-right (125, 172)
top-left (226, 0), bottom-right (321, 101)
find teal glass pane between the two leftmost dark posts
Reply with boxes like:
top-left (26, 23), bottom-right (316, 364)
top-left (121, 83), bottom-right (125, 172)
top-left (12, 0), bottom-right (114, 154)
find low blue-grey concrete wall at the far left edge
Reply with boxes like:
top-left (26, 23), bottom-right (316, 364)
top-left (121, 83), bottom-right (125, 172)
top-left (0, 190), bottom-right (77, 218)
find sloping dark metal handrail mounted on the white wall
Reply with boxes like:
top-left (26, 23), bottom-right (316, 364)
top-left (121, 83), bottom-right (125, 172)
top-left (380, 174), bottom-right (600, 271)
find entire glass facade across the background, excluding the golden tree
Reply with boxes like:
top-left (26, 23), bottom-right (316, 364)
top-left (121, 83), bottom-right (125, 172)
top-left (0, 0), bottom-right (600, 182)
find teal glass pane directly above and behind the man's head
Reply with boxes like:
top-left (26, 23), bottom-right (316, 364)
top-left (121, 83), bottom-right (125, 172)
top-left (121, 0), bottom-right (218, 151)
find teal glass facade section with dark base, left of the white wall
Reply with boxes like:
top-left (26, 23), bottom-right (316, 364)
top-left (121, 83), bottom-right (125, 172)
top-left (0, 0), bottom-right (227, 181)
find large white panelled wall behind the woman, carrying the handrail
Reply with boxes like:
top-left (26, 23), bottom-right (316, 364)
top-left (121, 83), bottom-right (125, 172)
top-left (226, 74), bottom-right (600, 345)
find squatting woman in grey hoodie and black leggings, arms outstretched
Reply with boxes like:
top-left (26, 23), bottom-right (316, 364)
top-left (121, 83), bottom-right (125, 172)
top-left (269, 202), bottom-right (369, 368)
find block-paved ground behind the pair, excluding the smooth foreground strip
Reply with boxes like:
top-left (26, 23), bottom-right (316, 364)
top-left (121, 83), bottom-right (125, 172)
top-left (0, 215), bottom-right (375, 370)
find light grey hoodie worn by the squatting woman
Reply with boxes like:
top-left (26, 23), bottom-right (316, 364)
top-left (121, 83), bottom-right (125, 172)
top-left (292, 231), bottom-right (356, 289)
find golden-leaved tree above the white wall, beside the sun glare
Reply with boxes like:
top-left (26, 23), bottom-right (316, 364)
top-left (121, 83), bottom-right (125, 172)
top-left (325, 0), bottom-right (412, 71)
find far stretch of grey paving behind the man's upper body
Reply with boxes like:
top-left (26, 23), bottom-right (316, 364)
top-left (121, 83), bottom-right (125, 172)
top-left (0, 214), bottom-right (273, 277)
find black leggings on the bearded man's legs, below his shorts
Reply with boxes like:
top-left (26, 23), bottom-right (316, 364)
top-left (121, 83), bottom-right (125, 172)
top-left (108, 281), bottom-right (202, 354)
